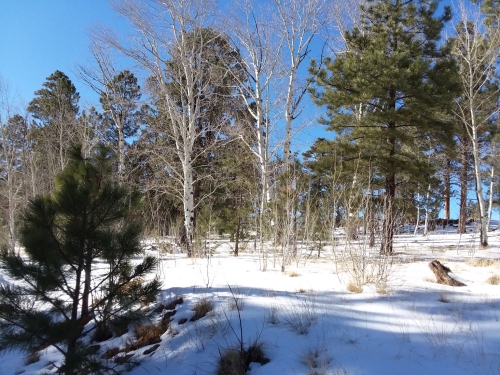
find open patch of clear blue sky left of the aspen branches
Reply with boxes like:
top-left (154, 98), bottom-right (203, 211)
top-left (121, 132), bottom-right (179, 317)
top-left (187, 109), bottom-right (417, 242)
top-left (0, 0), bottom-right (126, 103)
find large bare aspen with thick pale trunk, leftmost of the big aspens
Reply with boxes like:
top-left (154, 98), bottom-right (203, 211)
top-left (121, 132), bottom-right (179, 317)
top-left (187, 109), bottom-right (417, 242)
top-left (100, 0), bottom-right (237, 256)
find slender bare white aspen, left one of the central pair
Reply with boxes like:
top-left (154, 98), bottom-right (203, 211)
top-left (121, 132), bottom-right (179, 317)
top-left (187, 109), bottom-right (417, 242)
top-left (227, 0), bottom-right (283, 270)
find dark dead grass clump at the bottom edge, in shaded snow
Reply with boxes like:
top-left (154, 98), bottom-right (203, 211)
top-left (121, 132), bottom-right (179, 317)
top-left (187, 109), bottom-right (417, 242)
top-left (216, 342), bottom-right (269, 375)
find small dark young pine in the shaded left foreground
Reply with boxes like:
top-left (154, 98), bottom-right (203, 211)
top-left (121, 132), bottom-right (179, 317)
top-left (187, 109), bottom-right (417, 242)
top-left (0, 145), bottom-right (160, 374)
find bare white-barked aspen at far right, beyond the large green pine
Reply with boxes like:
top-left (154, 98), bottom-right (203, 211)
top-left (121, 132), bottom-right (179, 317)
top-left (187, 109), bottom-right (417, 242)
top-left (454, 3), bottom-right (500, 247)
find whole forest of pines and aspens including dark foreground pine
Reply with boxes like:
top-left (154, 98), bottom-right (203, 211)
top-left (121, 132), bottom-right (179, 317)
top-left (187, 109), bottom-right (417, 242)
top-left (0, 0), bottom-right (500, 374)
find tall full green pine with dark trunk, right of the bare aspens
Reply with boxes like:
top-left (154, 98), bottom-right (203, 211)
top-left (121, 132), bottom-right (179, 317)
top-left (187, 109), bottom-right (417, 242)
top-left (311, 0), bottom-right (458, 254)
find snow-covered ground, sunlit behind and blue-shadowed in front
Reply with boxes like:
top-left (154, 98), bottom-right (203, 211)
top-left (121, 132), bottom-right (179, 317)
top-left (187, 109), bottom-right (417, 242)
top-left (0, 228), bottom-right (500, 375)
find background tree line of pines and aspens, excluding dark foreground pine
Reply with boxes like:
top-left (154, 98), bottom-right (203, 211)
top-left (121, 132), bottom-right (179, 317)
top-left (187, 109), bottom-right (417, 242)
top-left (0, 0), bottom-right (500, 260)
